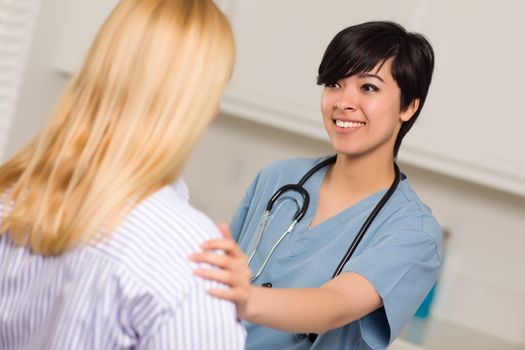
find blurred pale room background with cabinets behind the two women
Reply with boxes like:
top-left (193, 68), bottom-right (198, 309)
top-left (0, 0), bottom-right (525, 349)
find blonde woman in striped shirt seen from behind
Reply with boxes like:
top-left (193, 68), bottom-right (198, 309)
top-left (0, 0), bottom-right (244, 349)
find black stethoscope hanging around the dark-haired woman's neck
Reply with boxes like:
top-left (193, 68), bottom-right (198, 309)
top-left (244, 156), bottom-right (401, 282)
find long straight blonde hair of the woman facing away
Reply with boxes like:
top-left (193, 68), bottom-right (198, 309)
top-left (0, 0), bottom-right (234, 255)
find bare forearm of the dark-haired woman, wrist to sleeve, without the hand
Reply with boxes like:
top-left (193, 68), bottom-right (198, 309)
top-left (241, 272), bottom-right (383, 334)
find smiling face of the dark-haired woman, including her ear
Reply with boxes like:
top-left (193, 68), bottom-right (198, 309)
top-left (321, 59), bottom-right (417, 158)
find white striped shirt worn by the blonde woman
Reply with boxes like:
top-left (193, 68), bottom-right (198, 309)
top-left (0, 181), bottom-right (245, 350)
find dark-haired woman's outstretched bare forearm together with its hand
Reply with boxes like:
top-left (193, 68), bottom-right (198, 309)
top-left (190, 228), bottom-right (382, 334)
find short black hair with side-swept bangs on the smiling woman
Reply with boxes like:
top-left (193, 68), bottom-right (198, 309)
top-left (317, 21), bottom-right (434, 158)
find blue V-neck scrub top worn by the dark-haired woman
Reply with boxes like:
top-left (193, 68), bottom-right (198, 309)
top-left (231, 158), bottom-right (441, 350)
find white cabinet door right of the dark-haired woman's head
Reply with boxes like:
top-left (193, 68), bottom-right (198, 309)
top-left (402, 0), bottom-right (525, 196)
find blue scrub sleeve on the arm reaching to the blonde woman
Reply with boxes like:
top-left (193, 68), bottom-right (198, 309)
top-left (344, 217), bottom-right (441, 349)
